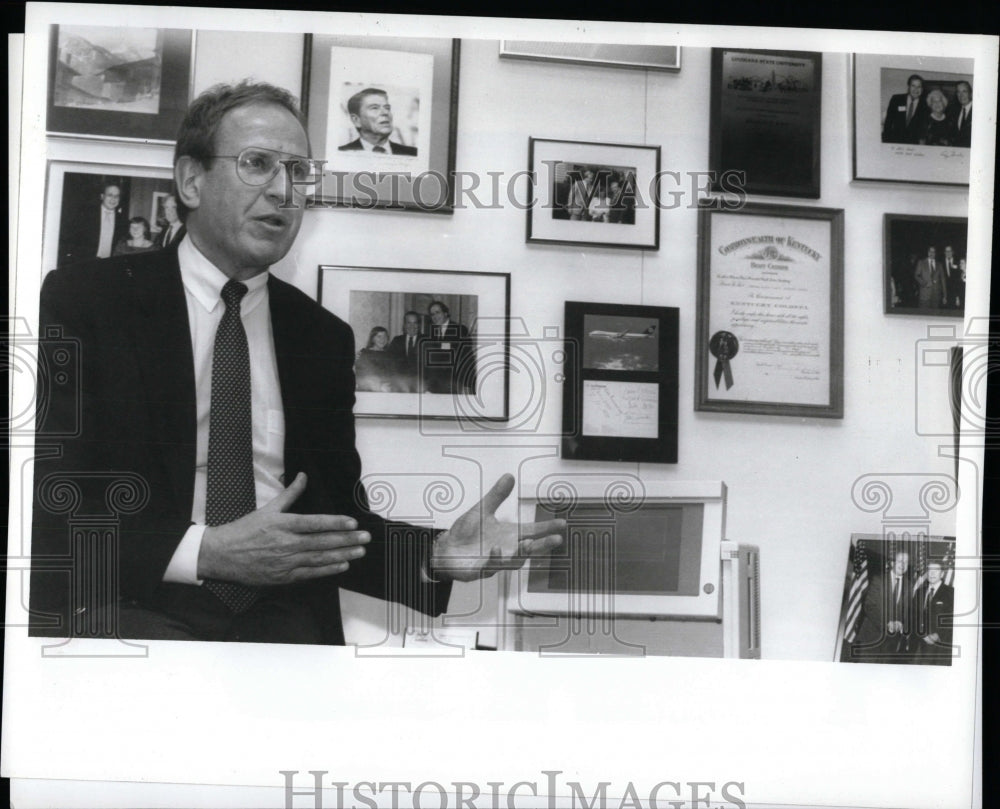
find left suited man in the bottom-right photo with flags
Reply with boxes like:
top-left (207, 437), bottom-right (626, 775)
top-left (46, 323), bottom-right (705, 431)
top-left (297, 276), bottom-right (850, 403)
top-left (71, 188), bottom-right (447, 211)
top-left (852, 550), bottom-right (913, 663)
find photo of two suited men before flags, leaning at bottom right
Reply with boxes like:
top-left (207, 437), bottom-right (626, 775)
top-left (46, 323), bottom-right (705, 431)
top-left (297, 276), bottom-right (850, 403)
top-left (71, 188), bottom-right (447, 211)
top-left (834, 533), bottom-right (955, 666)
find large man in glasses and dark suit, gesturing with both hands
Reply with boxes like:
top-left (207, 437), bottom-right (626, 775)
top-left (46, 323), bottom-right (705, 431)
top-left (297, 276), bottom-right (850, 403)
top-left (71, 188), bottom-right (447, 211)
top-left (30, 81), bottom-right (564, 644)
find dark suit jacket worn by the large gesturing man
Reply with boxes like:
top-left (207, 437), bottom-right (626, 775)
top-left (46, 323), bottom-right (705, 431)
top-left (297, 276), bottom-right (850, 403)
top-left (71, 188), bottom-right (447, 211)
top-left (30, 246), bottom-right (450, 644)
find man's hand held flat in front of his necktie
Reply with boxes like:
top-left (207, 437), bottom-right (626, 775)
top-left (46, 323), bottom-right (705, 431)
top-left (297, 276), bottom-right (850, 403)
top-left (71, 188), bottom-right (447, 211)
top-left (198, 473), bottom-right (371, 585)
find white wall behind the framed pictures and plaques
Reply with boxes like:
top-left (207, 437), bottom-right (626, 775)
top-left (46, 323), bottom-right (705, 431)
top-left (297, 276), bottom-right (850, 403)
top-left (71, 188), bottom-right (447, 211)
top-left (54, 32), bottom-right (967, 660)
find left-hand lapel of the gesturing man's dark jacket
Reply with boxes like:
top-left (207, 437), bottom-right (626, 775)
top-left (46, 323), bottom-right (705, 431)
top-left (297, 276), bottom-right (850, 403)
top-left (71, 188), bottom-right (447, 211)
top-left (123, 246), bottom-right (197, 510)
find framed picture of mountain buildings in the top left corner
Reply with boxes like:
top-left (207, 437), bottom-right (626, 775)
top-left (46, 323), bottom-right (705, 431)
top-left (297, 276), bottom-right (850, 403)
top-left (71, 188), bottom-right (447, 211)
top-left (46, 25), bottom-right (194, 143)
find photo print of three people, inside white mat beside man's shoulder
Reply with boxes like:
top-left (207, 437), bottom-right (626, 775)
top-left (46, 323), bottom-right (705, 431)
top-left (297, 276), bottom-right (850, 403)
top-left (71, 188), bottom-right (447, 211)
top-left (350, 291), bottom-right (479, 395)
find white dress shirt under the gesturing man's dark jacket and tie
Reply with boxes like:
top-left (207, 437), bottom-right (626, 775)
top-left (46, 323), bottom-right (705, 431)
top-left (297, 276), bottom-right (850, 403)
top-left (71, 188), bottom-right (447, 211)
top-left (163, 237), bottom-right (285, 584)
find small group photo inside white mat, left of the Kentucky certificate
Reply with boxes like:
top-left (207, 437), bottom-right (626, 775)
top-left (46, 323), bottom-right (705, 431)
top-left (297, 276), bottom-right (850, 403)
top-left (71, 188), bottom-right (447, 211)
top-left (552, 162), bottom-right (636, 225)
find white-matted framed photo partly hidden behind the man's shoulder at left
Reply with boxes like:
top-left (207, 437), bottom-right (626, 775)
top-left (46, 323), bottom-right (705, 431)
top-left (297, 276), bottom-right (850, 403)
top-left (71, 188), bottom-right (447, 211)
top-left (42, 160), bottom-right (174, 271)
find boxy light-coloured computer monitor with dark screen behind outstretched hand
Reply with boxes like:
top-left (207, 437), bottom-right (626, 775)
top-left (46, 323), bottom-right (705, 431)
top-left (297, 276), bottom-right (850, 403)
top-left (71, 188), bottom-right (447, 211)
top-left (508, 474), bottom-right (726, 620)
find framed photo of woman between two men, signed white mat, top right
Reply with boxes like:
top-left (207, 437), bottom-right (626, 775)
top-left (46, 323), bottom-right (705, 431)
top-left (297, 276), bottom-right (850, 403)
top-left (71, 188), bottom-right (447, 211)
top-left (852, 53), bottom-right (973, 185)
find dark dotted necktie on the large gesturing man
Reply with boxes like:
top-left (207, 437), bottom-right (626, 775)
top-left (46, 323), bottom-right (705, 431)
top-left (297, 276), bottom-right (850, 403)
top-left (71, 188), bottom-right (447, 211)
top-left (205, 281), bottom-right (260, 614)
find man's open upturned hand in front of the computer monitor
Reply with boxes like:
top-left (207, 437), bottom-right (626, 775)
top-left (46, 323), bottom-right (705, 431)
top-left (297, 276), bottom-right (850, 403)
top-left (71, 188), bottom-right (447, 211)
top-left (429, 475), bottom-right (566, 581)
